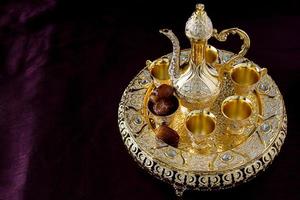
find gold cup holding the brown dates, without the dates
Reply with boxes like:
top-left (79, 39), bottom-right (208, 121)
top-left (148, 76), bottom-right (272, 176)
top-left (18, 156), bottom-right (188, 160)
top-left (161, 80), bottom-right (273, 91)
top-left (147, 96), bottom-right (179, 126)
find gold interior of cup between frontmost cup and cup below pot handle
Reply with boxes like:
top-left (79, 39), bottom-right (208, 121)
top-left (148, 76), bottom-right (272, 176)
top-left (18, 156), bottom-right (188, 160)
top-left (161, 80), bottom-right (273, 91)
top-left (221, 96), bottom-right (252, 120)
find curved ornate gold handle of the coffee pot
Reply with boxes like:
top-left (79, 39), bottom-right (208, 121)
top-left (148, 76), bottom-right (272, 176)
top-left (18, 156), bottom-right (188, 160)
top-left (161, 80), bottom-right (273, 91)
top-left (213, 28), bottom-right (250, 68)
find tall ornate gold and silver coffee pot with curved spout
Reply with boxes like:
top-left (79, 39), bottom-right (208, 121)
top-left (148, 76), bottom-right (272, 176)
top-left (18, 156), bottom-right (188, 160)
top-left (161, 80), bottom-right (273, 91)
top-left (160, 4), bottom-right (250, 110)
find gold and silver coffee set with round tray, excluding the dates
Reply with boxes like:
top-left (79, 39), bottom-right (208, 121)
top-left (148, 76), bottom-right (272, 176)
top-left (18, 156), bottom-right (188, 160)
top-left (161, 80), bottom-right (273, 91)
top-left (118, 4), bottom-right (287, 195)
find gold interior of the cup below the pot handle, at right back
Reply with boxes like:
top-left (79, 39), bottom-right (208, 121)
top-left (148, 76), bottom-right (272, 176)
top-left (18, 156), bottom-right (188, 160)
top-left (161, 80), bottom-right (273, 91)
top-left (231, 66), bottom-right (260, 86)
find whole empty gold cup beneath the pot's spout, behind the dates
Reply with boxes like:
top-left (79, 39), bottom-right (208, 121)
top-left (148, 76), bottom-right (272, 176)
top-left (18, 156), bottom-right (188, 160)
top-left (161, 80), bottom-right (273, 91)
top-left (148, 58), bottom-right (171, 87)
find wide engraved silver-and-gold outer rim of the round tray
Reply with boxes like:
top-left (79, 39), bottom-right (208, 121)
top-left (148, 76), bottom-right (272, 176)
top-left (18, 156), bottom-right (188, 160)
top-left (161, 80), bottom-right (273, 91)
top-left (118, 49), bottom-right (287, 190)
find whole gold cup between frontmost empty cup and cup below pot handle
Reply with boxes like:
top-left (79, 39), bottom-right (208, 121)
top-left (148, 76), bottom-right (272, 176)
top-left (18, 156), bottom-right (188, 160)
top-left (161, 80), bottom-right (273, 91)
top-left (221, 95), bottom-right (253, 134)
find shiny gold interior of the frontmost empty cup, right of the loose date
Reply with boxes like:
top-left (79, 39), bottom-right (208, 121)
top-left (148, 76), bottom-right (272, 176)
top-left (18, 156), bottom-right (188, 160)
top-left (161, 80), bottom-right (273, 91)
top-left (186, 113), bottom-right (216, 136)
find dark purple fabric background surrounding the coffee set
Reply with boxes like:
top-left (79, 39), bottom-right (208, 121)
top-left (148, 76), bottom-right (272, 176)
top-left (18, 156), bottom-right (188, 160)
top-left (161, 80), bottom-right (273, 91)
top-left (0, 0), bottom-right (300, 200)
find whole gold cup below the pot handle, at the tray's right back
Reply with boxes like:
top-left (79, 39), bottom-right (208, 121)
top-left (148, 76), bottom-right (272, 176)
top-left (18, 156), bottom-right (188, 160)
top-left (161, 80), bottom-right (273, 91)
top-left (230, 62), bottom-right (267, 96)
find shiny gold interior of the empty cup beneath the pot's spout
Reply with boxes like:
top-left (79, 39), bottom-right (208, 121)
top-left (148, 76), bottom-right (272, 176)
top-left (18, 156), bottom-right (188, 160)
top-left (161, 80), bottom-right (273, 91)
top-left (150, 58), bottom-right (170, 80)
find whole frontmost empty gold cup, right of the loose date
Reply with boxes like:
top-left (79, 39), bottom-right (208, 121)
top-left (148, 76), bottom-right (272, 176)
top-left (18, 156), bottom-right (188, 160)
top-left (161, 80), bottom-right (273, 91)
top-left (185, 110), bottom-right (217, 149)
